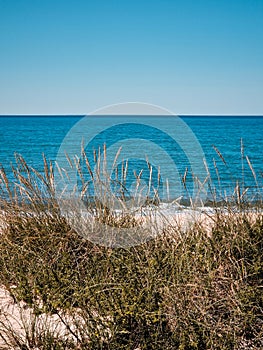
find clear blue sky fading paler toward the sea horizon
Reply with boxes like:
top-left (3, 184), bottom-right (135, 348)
top-left (0, 0), bottom-right (263, 115)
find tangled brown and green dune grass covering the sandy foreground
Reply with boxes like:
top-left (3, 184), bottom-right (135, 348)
top-left (0, 149), bottom-right (263, 350)
